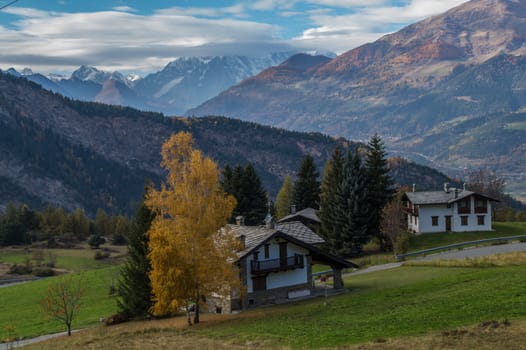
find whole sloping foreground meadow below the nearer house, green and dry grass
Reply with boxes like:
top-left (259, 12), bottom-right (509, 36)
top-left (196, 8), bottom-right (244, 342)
top-left (14, 256), bottom-right (526, 349)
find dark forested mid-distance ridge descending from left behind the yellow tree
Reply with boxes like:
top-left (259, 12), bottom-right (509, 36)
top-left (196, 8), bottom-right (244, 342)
top-left (0, 72), bottom-right (458, 215)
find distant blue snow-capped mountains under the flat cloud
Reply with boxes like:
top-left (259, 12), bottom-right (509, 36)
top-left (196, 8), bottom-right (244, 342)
top-left (6, 52), bottom-right (293, 115)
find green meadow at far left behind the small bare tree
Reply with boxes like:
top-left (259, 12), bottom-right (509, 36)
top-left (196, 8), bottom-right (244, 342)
top-left (0, 267), bottom-right (118, 341)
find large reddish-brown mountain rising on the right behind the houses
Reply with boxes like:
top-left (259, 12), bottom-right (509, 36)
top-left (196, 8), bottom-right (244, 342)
top-left (186, 0), bottom-right (526, 198)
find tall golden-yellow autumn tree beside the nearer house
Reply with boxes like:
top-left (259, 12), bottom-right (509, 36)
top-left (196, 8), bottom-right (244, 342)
top-left (146, 132), bottom-right (240, 323)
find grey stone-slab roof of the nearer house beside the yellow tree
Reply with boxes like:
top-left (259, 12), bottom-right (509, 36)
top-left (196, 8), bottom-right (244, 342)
top-left (229, 221), bottom-right (358, 267)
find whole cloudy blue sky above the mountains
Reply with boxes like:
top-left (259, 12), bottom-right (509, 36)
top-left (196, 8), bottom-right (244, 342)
top-left (0, 0), bottom-right (466, 75)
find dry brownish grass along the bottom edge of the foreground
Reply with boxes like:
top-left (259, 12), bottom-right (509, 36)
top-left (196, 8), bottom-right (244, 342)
top-left (21, 318), bottom-right (526, 350)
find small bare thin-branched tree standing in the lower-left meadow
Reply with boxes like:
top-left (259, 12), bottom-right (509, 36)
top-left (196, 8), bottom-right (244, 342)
top-left (40, 275), bottom-right (84, 335)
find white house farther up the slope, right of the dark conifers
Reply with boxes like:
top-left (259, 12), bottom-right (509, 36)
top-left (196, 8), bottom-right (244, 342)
top-left (404, 183), bottom-right (498, 233)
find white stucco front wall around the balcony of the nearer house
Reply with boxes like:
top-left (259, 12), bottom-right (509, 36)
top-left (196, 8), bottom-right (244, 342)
top-left (246, 240), bottom-right (309, 293)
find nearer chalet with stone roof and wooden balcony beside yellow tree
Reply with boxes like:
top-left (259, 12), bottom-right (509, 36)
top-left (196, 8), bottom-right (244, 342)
top-left (209, 221), bottom-right (358, 312)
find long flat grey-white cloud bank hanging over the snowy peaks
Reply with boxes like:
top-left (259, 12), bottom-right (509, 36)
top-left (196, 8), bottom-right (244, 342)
top-left (0, 9), bottom-right (291, 71)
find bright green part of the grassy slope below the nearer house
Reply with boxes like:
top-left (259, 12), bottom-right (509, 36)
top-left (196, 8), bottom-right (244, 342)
top-left (198, 266), bottom-right (526, 348)
